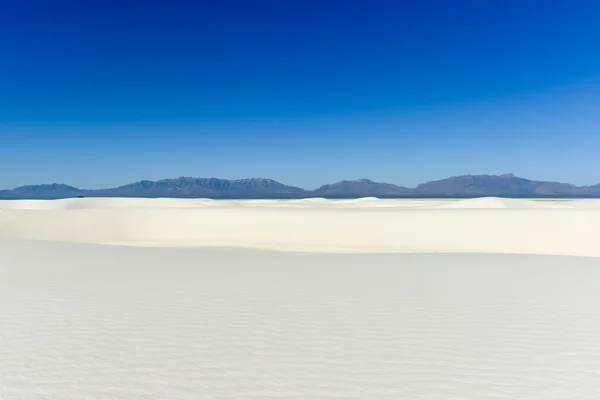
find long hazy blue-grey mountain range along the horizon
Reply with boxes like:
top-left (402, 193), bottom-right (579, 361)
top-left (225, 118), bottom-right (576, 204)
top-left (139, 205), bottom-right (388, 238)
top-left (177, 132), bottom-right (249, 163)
top-left (0, 174), bottom-right (600, 200)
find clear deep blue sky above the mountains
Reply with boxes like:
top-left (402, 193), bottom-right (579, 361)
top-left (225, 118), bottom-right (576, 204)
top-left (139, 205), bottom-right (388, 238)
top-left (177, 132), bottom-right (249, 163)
top-left (0, 0), bottom-right (600, 188)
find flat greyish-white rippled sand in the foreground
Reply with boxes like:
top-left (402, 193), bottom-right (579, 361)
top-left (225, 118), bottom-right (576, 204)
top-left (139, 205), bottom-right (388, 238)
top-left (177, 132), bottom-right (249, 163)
top-left (0, 239), bottom-right (600, 400)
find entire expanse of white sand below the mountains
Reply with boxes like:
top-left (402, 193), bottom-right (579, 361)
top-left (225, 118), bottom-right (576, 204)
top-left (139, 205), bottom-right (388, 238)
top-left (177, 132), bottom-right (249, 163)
top-left (0, 199), bottom-right (600, 400)
